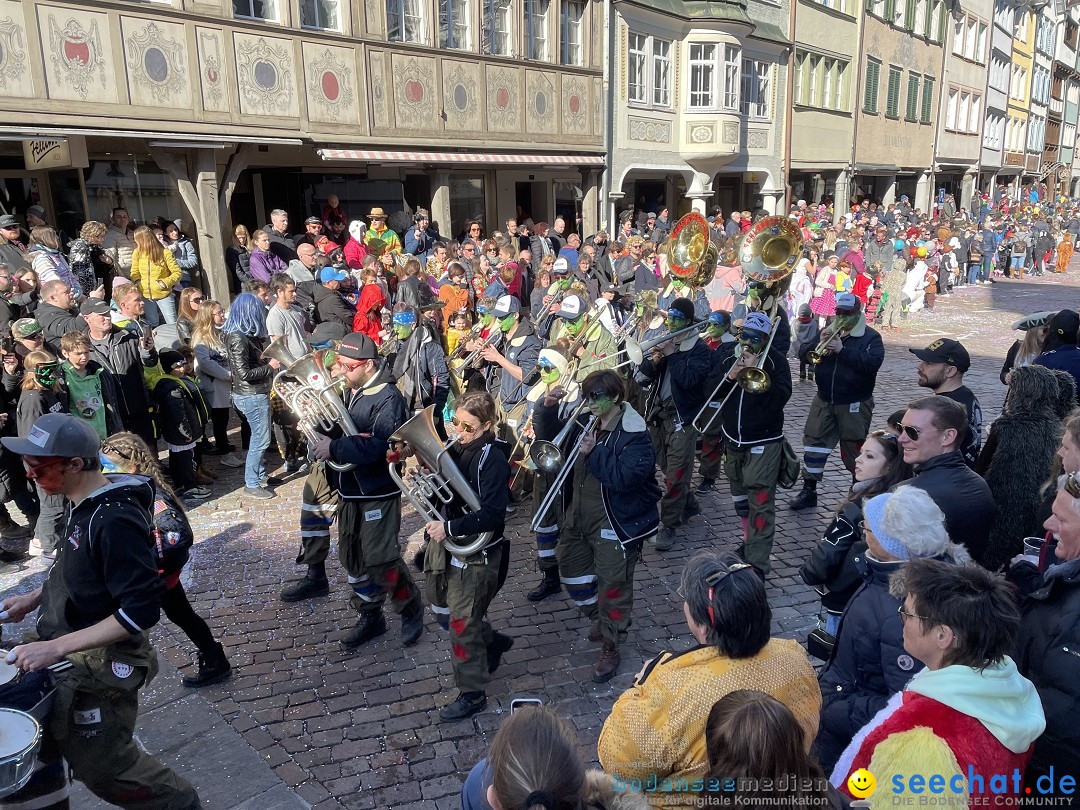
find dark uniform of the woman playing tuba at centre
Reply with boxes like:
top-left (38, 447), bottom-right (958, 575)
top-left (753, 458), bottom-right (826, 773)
top-left (424, 399), bottom-right (513, 720)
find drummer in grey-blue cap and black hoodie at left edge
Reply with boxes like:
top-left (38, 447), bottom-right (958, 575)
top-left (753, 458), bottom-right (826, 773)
top-left (0, 414), bottom-right (202, 810)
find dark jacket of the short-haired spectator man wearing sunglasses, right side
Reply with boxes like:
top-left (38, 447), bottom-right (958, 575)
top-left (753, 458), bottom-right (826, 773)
top-left (905, 450), bottom-right (997, 566)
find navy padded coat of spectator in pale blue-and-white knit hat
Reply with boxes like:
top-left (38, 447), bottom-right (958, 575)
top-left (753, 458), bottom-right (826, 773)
top-left (814, 543), bottom-right (970, 772)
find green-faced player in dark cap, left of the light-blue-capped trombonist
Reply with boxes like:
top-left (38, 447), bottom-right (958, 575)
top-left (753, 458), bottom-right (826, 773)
top-left (638, 298), bottom-right (713, 551)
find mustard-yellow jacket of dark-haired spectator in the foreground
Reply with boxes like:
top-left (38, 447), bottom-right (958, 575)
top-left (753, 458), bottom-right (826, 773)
top-left (596, 638), bottom-right (821, 808)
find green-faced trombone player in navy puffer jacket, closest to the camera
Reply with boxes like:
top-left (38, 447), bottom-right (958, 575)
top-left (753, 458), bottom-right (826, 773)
top-left (536, 373), bottom-right (660, 683)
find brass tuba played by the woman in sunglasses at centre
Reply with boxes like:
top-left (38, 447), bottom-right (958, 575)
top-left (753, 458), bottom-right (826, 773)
top-left (390, 405), bottom-right (495, 561)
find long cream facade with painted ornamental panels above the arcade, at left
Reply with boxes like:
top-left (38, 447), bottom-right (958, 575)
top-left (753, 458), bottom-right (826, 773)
top-left (0, 0), bottom-right (606, 302)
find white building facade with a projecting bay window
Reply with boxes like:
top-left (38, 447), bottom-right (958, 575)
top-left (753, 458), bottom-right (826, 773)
top-left (606, 0), bottom-right (789, 221)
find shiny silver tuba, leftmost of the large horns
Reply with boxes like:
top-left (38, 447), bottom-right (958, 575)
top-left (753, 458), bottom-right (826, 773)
top-left (270, 349), bottom-right (357, 472)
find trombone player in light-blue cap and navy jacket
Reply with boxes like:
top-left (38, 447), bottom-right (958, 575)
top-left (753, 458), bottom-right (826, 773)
top-left (702, 312), bottom-right (792, 577)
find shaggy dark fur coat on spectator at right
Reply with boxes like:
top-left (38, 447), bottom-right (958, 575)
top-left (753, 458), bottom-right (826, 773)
top-left (975, 369), bottom-right (1062, 571)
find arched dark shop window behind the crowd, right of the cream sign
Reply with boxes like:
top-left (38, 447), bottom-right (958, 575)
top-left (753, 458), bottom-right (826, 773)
top-left (85, 154), bottom-right (188, 228)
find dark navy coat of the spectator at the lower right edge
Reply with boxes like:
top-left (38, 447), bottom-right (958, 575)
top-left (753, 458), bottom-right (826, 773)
top-left (1016, 559), bottom-right (1080, 787)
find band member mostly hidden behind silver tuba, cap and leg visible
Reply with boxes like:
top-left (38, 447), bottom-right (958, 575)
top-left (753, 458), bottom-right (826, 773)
top-left (280, 321), bottom-right (349, 602)
